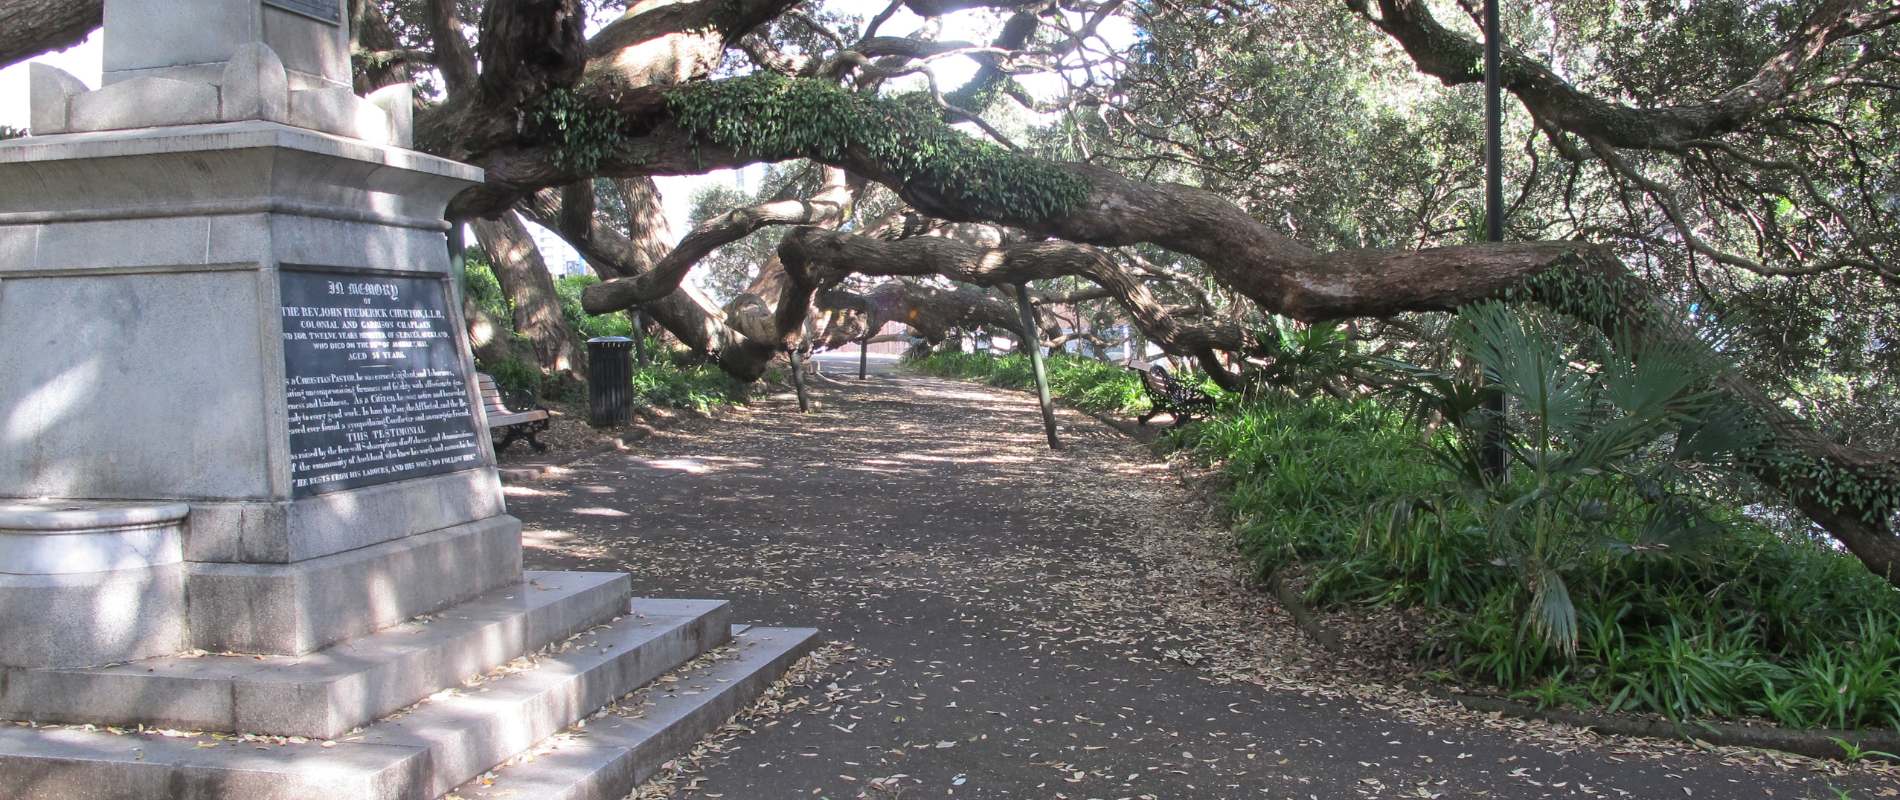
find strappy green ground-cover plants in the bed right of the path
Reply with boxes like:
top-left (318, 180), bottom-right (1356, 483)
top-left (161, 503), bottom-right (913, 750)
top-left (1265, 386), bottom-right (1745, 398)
top-left (1178, 397), bottom-right (1900, 728)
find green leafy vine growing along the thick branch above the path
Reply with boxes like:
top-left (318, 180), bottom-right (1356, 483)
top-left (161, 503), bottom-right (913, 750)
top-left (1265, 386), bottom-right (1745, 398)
top-left (667, 74), bottom-right (1091, 224)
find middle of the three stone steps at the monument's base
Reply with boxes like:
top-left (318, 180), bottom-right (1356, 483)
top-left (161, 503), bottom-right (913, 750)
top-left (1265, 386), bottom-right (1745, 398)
top-left (0, 600), bottom-right (730, 800)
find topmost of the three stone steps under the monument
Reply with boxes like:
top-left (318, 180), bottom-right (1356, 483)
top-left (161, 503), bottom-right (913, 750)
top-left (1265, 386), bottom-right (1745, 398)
top-left (0, 572), bottom-right (633, 739)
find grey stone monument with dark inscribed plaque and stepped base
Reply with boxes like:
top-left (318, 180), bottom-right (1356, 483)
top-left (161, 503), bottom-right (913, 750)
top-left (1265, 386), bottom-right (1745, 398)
top-left (0, 0), bottom-right (811, 798)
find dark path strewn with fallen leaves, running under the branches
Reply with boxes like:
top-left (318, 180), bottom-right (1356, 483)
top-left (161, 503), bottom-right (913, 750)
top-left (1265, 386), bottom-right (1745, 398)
top-left (509, 363), bottom-right (1900, 800)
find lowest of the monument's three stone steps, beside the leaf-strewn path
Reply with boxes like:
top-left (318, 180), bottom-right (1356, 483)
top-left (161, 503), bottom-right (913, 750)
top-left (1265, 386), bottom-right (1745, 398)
top-left (454, 625), bottom-right (819, 800)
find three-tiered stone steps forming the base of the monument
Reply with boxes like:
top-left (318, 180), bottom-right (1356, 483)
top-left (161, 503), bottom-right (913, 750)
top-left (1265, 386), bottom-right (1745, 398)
top-left (0, 572), bottom-right (817, 800)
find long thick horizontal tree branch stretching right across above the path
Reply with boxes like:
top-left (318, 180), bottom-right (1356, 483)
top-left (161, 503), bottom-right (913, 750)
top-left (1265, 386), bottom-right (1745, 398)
top-left (463, 78), bottom-right (1900, 581)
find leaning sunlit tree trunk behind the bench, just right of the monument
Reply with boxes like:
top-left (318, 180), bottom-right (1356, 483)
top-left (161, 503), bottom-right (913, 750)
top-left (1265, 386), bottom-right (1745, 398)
top-left (473, 211), bottom-right (587, 380)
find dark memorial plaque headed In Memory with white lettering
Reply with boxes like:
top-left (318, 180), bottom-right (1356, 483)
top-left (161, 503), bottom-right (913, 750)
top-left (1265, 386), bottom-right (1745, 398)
top-left (279, 270), bottom-right (483, 498)
